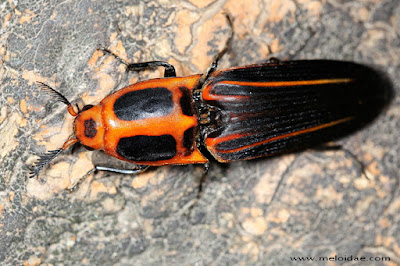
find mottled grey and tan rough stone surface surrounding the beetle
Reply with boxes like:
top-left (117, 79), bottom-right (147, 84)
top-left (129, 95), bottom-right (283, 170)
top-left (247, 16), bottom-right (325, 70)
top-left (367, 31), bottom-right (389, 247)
top-left (0, 0), bottom-right (400, 265)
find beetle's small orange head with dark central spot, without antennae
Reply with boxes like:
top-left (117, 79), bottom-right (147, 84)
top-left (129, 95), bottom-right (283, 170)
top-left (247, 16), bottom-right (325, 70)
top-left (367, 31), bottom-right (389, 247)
top-left (74, 105), bottom-right (104, 150)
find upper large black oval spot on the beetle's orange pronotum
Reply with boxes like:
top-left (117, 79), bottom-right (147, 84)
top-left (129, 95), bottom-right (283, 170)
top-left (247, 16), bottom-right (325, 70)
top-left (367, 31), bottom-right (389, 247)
top-left (114, 88), bottom-right (174, 121)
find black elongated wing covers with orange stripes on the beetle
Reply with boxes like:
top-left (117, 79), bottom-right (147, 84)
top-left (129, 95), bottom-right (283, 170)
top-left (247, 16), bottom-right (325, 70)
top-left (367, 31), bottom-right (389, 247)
top-left (203, 60), bottom-right (390, 162)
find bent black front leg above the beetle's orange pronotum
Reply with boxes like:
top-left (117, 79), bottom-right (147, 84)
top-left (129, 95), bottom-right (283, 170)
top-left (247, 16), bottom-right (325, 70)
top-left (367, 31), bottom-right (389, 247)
top-left (98, 47), bottom-right (176, 77)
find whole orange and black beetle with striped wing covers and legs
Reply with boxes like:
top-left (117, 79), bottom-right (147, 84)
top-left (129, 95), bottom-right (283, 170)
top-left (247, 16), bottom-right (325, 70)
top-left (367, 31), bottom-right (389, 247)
top-left (30, 25), bottom-right (391, 190)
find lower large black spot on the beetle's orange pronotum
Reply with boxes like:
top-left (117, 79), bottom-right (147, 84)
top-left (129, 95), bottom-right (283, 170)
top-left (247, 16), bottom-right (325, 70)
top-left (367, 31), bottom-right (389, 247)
top-left (117, 135), bottom-right (176, 161)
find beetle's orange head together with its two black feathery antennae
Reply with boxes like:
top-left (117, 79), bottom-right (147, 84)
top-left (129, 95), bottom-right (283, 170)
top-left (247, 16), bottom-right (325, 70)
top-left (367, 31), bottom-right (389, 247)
top-left (29, 82), bottom-right (104, 178)
